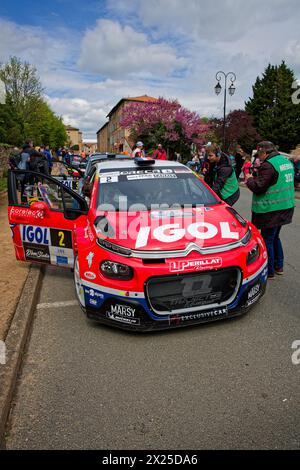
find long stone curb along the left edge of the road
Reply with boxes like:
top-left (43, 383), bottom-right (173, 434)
top-left (0, 265), bottom-right (44, 449)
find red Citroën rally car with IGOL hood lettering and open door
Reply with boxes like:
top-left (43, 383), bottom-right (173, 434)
top-left (8, 157), bottom-right (267, 331)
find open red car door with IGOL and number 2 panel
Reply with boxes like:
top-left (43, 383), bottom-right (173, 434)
top-left (8, 170), bottom-right (88, 268)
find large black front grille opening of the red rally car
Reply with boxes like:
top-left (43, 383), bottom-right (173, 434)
top-left (146, 267), bottom-right (241, 315)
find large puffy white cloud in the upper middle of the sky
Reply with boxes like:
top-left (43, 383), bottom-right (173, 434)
top-left (79, 20), bottom-right (185, 77)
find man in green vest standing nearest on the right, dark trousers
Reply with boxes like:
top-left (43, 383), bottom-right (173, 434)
top-left (245, 141), bottom-right (295, 279)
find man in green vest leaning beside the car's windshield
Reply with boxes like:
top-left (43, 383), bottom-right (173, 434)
top-left (206, 145), bottom-right (240, 206)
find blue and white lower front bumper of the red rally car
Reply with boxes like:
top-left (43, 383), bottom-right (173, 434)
top-left (83, 263), bottom-right (267, 332)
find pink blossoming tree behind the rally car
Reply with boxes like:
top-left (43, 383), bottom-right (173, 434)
top-left (121, 98), bottom-right (209, 157)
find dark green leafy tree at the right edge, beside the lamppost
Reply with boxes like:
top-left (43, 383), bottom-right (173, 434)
top-left (246, 61), bottom-right (300, 152)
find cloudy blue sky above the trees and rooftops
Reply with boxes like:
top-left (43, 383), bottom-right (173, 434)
top-left (0, 0), bottom-right (300, 140)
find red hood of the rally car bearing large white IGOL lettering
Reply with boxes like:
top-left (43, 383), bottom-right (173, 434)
top-left (95, 204), bottom-right (248, 251)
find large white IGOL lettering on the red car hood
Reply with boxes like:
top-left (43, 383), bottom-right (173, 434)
top-left (135, 222), bottom-right (239, 248)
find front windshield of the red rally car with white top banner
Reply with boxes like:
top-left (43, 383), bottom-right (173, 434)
top-left (97, 167), bottom-right (219, 212)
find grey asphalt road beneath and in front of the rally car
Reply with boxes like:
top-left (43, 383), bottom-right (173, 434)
top-left (7, 189), bottom-right (300, 449)
